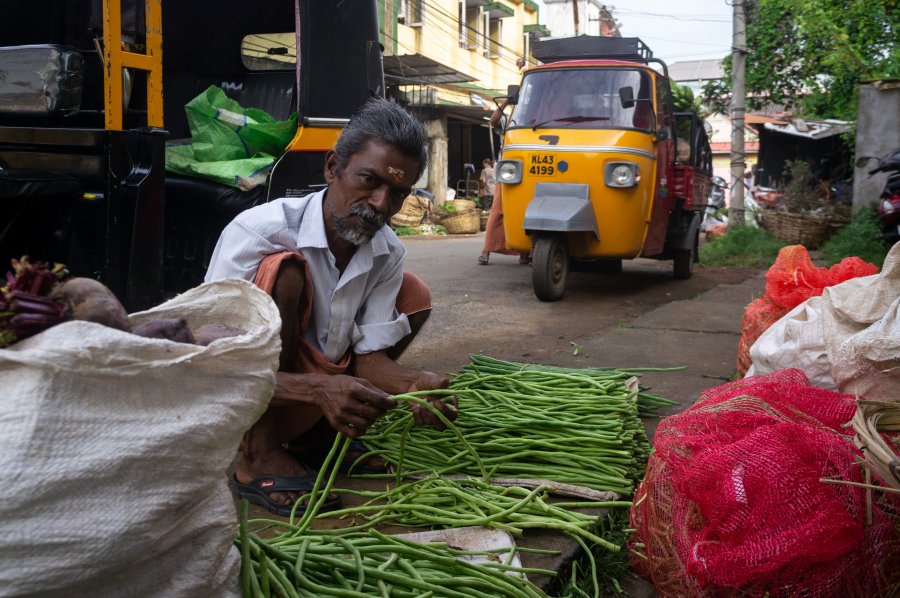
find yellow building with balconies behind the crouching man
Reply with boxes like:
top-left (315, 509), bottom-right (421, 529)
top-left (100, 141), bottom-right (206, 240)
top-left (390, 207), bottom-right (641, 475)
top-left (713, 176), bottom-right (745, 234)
top-left (378, 0), bottom-right (549, 201)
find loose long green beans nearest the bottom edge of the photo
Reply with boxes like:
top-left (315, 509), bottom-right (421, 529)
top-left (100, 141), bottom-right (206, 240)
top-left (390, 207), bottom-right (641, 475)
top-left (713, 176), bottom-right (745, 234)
top-left (237, 420), bottom-right (555, 598)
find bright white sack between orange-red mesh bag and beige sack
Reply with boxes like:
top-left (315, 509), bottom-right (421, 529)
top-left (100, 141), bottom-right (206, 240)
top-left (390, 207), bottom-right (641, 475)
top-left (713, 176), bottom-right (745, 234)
top-left (747, 297), bottom-right (836, 390)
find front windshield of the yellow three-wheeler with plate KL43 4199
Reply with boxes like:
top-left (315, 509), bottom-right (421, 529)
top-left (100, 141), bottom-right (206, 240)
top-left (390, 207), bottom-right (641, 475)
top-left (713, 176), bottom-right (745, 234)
top-left (509, 68), bottom-right (653, 130)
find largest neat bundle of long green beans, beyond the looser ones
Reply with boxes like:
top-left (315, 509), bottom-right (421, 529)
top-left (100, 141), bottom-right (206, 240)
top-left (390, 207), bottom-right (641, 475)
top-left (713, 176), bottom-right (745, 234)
top-left (363, 356), bottom-right (665, 495)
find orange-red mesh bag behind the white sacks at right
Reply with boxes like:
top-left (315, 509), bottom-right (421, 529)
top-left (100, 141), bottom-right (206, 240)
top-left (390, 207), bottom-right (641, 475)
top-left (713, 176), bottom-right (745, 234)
top-left (737, 245), bottom-right (878, 376)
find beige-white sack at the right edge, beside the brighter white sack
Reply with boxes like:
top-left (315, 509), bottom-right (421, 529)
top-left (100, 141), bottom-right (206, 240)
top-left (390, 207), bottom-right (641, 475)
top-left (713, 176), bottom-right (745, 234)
top-left (822, 243), bottom-right (900, 401)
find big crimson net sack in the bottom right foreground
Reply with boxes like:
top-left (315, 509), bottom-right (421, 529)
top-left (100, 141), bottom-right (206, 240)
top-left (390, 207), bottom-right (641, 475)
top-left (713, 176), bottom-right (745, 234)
top-left (631, 370), bottom-right (900, 597)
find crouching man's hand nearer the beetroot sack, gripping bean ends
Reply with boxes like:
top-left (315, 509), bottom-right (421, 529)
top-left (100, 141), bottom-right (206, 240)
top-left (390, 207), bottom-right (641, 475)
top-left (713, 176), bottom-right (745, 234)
top-left (313, 375), bottom-right (397, 438)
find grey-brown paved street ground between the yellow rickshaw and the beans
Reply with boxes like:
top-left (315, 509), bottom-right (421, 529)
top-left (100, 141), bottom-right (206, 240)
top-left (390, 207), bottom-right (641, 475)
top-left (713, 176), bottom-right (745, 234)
top-left (234, 234), bottom-right (765, 596)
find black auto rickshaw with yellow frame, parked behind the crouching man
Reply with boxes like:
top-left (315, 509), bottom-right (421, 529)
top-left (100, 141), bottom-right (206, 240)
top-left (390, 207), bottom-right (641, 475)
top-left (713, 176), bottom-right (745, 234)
top-left (0, 0), bottom-right (385, 311)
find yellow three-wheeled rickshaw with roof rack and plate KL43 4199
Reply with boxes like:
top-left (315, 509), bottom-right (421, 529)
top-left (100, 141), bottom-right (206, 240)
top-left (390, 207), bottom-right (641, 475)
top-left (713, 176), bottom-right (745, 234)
top-left (496, 35), bottom-right (712, 301)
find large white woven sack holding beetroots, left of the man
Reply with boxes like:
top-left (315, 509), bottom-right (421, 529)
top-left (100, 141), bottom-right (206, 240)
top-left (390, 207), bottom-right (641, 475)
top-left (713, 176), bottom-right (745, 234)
top-left (0, 280), bottom-right (281, 598)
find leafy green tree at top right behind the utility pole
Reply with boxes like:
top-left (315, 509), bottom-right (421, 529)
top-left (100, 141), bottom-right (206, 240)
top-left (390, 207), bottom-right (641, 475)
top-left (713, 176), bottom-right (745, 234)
top-left (703, 0), bottom-right (900, 120)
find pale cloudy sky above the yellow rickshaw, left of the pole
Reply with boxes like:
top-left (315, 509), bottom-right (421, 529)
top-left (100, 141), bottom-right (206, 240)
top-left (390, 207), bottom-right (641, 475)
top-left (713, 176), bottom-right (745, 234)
top-left (544, 0), bottom-right (733, 64)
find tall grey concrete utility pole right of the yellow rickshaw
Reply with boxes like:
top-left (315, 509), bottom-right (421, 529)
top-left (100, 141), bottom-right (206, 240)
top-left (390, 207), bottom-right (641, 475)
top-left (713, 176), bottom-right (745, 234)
top-left (728, 0), bottom-right (747, 230)
